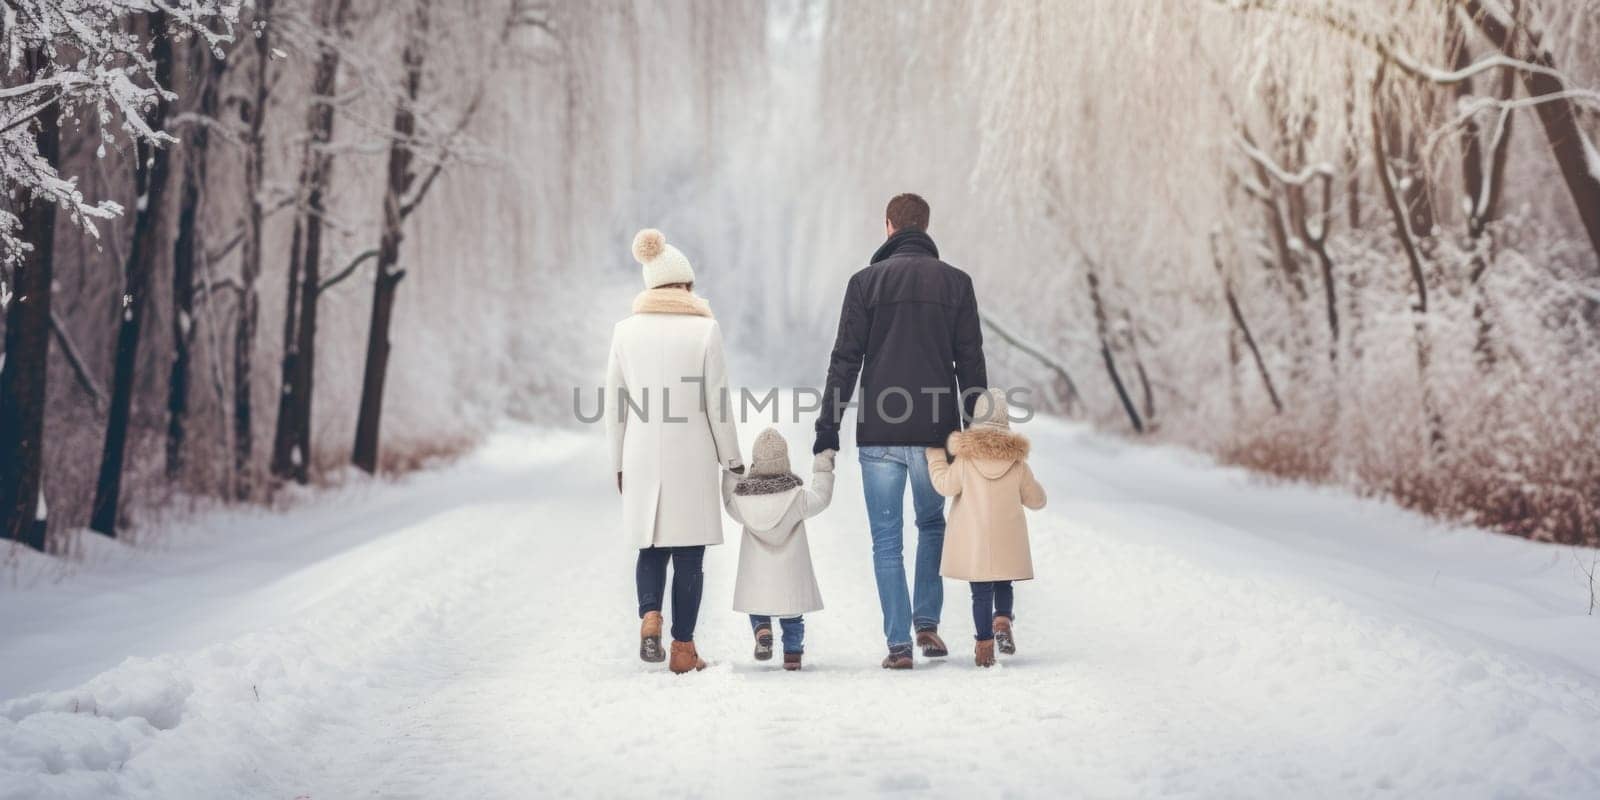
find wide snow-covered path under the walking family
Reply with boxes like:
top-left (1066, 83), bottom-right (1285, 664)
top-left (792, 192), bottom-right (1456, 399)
top-left (0, 409), bottom-right (1600, 800)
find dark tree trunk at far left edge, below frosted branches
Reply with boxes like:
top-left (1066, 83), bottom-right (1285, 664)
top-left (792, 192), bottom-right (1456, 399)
top-left (0, 50), bottom-right (61, 550)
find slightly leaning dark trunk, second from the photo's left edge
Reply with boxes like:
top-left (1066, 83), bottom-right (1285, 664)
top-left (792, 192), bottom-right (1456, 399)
top-left (90, 11), bottom-right (173, 536)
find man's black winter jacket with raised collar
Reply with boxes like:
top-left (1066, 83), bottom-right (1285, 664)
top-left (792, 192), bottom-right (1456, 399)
top-left (811, 230), bottom-right (989, 453)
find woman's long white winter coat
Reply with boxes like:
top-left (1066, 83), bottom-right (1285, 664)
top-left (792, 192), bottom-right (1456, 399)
top-left (605, 288), bottom-right (744, 549)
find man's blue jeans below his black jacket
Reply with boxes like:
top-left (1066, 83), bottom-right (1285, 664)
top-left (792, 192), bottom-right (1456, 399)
top-left (861, 445), bottom-right (944, 650)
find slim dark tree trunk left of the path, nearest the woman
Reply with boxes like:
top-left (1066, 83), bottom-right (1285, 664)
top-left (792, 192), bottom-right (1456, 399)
top-left (350, 0), bottom-right (430, 474)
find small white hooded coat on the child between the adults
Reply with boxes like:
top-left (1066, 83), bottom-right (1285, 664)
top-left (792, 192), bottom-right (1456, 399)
top-left (722, 453), bottom-right (834, 618)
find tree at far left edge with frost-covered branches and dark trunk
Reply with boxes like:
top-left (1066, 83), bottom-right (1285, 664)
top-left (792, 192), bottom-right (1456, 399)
top-left (0, 0), bottom-right (238, 544)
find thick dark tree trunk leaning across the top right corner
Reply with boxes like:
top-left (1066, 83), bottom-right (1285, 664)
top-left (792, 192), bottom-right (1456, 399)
top-left (1458, 0), bottom-right (1600, 269)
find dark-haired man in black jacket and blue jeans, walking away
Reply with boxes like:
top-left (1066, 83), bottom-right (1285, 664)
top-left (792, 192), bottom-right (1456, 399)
top-left (811, 194), bottom-right (989, 669)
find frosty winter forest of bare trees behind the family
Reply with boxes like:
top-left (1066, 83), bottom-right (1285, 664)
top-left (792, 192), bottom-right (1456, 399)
top-left (0, 0), bottom-right (1600, 552)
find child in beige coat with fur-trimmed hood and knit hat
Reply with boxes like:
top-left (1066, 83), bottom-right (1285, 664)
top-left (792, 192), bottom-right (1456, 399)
top-left (926, 389), bottom-right (1045, 667)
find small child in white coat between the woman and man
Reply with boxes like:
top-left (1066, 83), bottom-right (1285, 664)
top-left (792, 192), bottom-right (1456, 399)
top-left (722, 427), bottom-right (834, 670)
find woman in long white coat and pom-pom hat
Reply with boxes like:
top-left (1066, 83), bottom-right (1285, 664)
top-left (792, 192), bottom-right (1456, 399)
top-left (605, 229), bottom-right (744, 674)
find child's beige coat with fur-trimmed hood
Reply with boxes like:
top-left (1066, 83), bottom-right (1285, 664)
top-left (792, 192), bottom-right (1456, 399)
top-left (926, 427), bottom-right (1045, 581)
